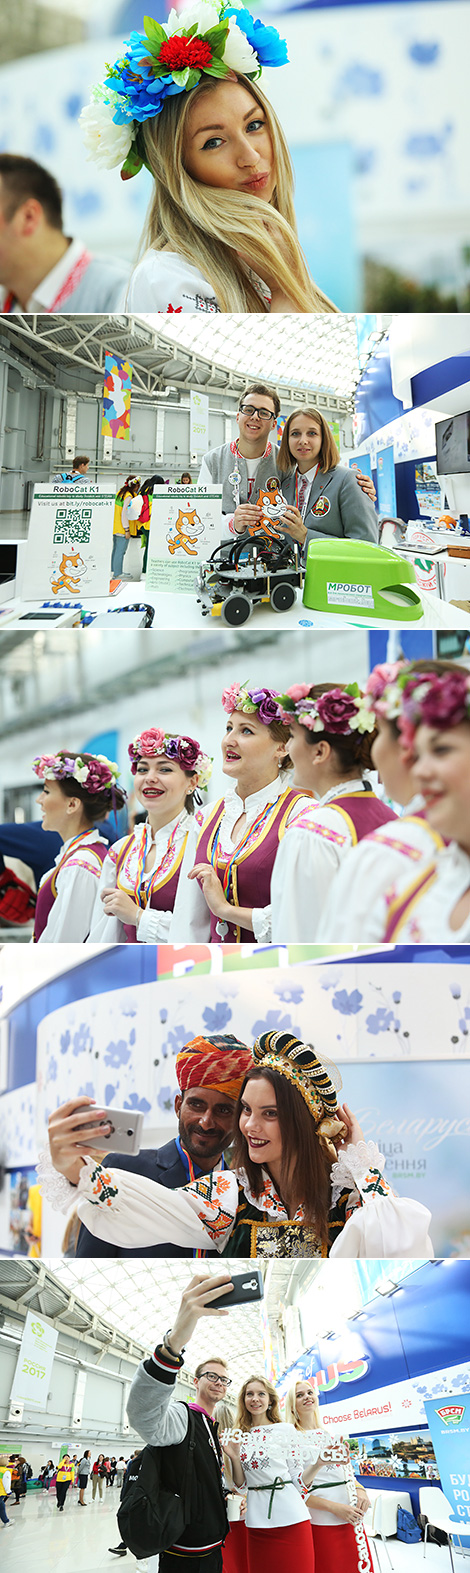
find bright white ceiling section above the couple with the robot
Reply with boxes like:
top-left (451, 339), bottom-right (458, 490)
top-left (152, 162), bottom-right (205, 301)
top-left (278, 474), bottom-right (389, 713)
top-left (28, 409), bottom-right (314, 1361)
top-left (141, 311), bottom-right (382, 398)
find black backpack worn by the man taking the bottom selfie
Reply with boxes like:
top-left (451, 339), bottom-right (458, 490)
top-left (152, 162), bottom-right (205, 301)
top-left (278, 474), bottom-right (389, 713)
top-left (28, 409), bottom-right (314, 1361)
top-left (118, 1409), bottom-right (196, 1559)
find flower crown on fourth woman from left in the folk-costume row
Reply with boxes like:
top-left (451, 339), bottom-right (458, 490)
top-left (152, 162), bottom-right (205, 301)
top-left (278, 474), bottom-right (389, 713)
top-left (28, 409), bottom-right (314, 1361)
top-left (277, 683), bottom-right (376, 738)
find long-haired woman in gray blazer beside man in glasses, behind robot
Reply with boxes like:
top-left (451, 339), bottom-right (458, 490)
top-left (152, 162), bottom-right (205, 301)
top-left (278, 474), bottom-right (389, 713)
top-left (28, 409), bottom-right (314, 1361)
top-left (277, 409), bottom-right (379, 558)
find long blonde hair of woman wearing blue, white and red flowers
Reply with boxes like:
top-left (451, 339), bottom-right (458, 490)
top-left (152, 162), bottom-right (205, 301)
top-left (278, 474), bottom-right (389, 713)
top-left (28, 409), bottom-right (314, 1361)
top-left (141, 74), bottom-right (336, 313)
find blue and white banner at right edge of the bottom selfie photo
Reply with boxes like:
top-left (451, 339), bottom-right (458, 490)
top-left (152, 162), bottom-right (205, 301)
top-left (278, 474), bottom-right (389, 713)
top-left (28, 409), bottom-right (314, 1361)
top-left (424, 1392), bottom-right (470, 1524)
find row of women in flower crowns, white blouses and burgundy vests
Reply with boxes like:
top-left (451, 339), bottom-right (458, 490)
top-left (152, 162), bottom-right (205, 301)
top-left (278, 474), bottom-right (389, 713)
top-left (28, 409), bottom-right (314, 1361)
top-left (33, 661), bottom-right (470, 944)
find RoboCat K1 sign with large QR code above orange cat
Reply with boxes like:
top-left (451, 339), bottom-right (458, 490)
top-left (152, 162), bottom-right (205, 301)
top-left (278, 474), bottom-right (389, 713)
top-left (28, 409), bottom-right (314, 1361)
top-left (22, 483), bottom-right (115, 604)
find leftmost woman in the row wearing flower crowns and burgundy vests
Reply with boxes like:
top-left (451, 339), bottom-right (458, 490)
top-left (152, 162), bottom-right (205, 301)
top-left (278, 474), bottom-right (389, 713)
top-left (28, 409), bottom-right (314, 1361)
top-left (33, 749), bottom-right (126, 944)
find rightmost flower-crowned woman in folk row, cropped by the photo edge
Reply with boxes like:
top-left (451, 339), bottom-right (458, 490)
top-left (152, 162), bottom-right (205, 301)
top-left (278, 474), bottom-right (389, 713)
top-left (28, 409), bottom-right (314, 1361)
top-left (372, 661), bottom-right (470, 944)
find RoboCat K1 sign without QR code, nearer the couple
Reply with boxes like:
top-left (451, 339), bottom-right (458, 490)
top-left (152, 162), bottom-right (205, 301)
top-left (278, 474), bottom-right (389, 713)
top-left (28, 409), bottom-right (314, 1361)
top-left (145, 486), bottom-right (223, 595)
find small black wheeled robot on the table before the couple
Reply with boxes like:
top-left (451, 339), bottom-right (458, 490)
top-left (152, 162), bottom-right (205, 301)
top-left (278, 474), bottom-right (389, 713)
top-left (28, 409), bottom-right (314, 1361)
top-left (198, 530), bottom-right (303, 628)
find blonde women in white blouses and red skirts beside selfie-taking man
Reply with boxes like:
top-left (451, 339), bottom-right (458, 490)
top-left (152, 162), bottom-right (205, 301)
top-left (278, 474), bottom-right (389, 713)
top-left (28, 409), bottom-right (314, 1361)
top-left (215, 1376), bottom-right (373, 1573)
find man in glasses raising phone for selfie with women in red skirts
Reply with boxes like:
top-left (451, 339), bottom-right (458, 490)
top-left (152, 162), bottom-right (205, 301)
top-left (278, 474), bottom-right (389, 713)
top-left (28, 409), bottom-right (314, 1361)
top-left (127, 1273), bottom-right (231, 1573)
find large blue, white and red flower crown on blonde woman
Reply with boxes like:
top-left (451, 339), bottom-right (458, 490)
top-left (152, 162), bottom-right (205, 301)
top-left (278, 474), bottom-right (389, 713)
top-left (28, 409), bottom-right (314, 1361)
top-left (80, 0), bottom-right (288, 181)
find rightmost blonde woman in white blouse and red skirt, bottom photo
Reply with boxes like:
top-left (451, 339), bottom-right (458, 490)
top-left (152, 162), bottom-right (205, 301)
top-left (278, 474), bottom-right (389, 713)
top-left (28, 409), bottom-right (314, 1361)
top-left (286, 1381), bottom-right (373, 1573)
